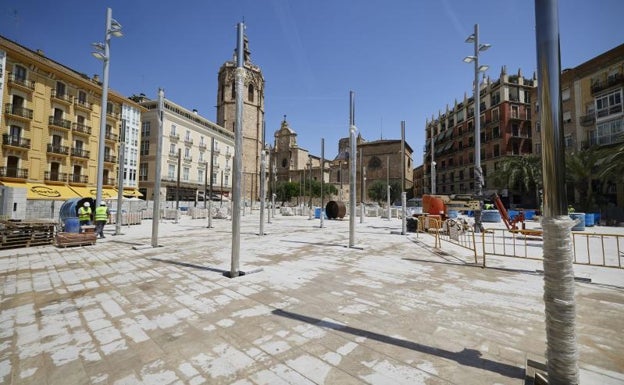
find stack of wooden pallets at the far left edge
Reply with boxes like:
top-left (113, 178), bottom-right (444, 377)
top-left (0, 220), bottom-right (55, 249)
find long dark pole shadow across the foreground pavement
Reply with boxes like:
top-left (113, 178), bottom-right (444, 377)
top-left (272, 309), bottom-right (525, 379)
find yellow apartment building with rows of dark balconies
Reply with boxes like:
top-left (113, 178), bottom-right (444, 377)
top-left (0, 36), bottom-right (143, 216)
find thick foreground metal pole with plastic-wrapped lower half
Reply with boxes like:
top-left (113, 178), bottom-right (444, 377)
top-left (535, 0), bottom-right (579, 385)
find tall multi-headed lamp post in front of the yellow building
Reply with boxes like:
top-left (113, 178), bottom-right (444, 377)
top-left (93, 8), bottom-right (123, 205)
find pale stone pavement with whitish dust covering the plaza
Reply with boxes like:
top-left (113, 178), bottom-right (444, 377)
top-left (0, 211), bottom-right (624, 385)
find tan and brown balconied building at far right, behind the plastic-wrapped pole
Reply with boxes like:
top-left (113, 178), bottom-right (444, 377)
top-left (532, 44), bottom-right (624, 207)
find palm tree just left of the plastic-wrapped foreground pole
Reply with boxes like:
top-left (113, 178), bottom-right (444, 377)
top-left (491, 154), bottom-right (543, 205)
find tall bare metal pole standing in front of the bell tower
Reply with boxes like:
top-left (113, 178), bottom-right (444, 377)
top-left (230, 23), bottom-right (245, 278)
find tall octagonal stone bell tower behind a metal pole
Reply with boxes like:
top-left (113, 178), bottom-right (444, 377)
top-left (217, 36), bottom-right (264, 200)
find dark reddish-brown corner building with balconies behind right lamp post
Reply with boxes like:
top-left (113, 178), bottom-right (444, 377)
top-left (423, 67), bottom-right (537, 202)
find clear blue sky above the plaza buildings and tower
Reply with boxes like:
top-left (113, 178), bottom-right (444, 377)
top-left (0, 0), bottom-right (624, 165)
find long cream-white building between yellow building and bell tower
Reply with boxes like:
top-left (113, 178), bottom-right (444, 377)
top-left (133, 95), bottom-right (234, 201)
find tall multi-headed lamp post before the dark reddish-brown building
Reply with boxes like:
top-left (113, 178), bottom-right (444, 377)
top-left (464, 24), bottom-right (491, 233)
